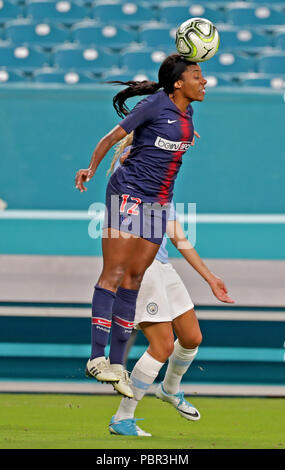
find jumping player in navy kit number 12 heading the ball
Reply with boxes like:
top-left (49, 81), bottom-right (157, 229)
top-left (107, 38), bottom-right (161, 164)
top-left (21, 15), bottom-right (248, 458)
top-left (76, 54), bottom-right (206, 397)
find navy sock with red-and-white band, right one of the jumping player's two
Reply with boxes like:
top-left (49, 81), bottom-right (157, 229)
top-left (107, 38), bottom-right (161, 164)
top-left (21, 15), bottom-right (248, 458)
top-left (109, 287), bottom-right (138, 364)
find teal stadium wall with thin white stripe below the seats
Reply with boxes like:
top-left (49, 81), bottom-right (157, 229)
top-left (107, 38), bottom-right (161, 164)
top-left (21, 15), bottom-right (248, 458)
top-left (0, 85), bottom-right (285, 259)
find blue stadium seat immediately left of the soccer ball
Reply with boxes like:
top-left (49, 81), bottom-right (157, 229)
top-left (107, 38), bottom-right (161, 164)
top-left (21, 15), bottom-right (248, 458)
top-left (139, 23), bottom-right (176, 48)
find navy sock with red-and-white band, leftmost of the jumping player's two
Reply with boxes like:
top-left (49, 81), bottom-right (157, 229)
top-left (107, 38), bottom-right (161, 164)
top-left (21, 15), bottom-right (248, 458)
top-left (90, 285), bottom-right (116, 359)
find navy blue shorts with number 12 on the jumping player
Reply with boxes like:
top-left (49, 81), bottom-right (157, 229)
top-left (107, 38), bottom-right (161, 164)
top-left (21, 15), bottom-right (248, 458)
top-left (103, 182), bottom-right (170, 245)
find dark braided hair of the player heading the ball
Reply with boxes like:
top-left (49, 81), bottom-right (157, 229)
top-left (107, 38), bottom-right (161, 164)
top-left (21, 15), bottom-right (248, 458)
top-left (108, 54), bottom-right (196, 118)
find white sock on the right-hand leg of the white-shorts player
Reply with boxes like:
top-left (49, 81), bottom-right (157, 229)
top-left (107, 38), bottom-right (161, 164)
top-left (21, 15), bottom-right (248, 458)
top-left (163, 339), bottom-right (198, 394)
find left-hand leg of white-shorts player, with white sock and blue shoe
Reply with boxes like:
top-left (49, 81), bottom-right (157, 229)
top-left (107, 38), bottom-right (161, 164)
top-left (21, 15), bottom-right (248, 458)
top-left (109, 322), bottom-right (174, 436)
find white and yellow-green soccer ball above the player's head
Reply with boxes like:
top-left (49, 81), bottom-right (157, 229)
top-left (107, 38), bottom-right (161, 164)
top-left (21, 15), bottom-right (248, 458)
top-left (175, 18), bottom-right (220, 62)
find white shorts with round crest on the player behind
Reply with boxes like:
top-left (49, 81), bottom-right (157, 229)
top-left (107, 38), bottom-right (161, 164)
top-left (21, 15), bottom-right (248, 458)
top-left (135, 260), bottom-right (194, 329)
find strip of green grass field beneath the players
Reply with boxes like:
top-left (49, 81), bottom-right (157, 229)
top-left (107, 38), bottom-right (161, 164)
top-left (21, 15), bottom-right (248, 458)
top-left (0, 394), bottom-right (285, 449)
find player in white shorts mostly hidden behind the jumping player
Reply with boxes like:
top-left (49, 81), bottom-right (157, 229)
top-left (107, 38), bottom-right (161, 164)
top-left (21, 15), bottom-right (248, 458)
top-left (109, 140), bottom-right (233, 436)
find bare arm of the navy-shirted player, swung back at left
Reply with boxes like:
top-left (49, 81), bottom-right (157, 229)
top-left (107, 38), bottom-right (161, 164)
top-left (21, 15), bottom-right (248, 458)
top-left (75, 125), bottom-right (127, 192)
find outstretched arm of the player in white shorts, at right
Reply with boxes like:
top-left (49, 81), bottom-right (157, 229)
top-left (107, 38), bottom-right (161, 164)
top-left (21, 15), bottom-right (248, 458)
top-left (167, 220), bottom-right (234, 303)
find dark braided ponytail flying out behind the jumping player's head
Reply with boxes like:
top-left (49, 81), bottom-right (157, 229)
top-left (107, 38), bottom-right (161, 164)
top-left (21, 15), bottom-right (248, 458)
top-left (108, 80), bottom-right (161, 118)
